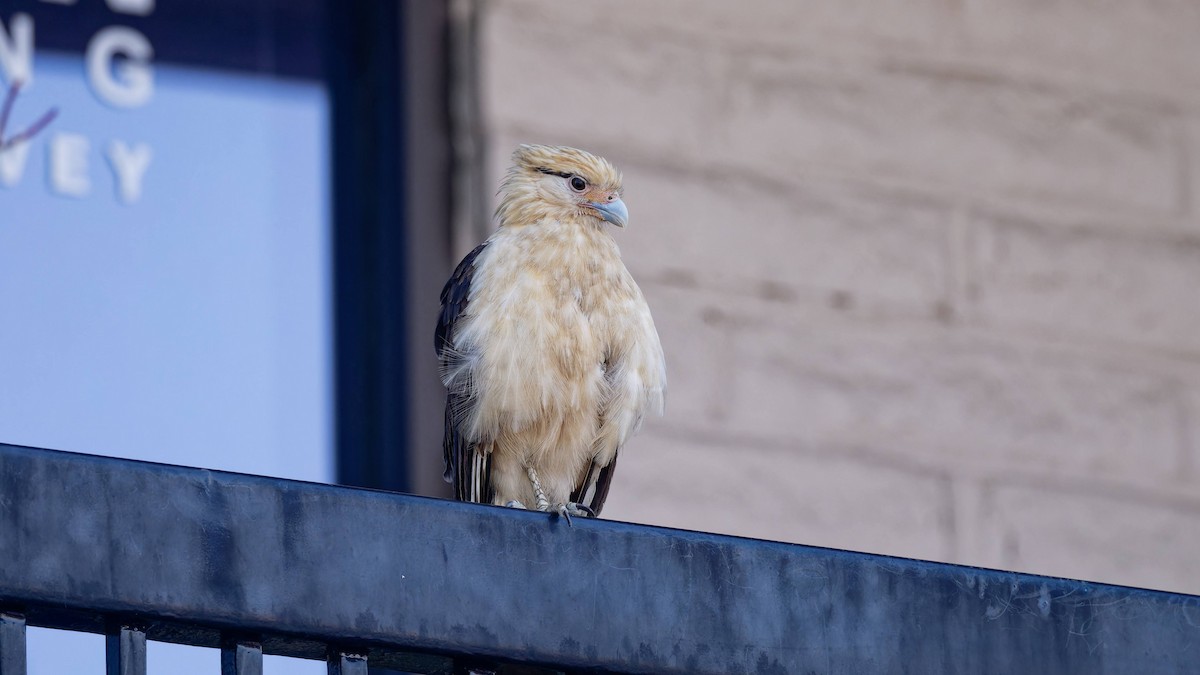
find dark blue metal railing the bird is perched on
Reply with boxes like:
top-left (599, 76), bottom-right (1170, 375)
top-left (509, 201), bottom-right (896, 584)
top-left (0, 446), bottom-right (1200, 675)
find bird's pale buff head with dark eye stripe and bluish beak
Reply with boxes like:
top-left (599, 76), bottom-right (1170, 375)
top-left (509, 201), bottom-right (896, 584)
top-left (497, 145), bottom-right (629, 227)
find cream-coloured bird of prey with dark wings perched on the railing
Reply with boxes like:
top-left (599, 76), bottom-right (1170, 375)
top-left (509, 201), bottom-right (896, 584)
top-left (434, 144), bottom-right (666, 524)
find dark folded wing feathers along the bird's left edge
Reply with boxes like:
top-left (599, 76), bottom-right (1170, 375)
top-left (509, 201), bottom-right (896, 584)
top-left (433, 241), bottom-right (492, 503)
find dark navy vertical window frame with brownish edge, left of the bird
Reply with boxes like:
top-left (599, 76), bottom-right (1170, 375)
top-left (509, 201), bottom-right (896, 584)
top-left (326, 0), bottom-right (452, 495)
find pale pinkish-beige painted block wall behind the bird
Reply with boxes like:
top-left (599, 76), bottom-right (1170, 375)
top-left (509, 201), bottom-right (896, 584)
top-left (479, 0), bottom-right (1200, 593)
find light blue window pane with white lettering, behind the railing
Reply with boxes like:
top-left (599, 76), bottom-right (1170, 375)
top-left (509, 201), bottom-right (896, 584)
top-left (0, 0), bottom-right (334, 673)
